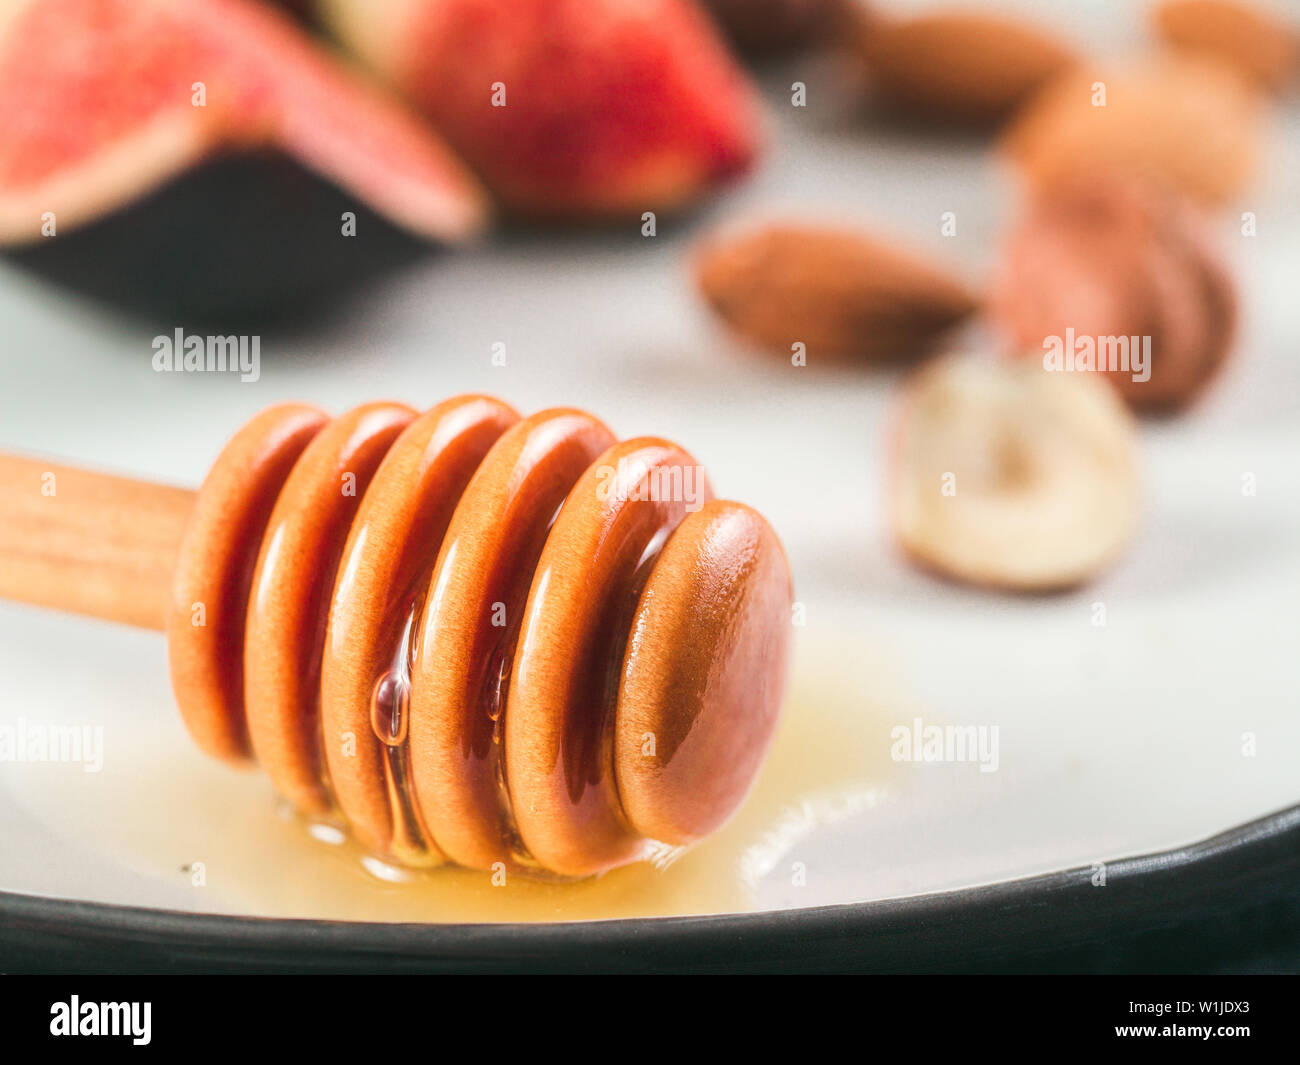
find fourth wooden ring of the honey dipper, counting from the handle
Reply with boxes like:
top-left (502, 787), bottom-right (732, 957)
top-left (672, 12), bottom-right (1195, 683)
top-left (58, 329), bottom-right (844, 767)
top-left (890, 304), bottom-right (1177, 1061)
top-left (411, 410), bottom-right (615, 869)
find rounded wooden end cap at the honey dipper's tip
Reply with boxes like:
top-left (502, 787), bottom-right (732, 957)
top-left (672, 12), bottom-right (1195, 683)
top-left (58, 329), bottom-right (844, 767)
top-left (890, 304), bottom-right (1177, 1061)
top-left (614, 499), bottom-right (792, 844)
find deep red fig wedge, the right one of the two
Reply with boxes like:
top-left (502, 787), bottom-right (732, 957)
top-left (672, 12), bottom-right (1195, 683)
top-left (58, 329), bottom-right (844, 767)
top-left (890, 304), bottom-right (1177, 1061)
top-left (319, 0), bottom-right (759, 218)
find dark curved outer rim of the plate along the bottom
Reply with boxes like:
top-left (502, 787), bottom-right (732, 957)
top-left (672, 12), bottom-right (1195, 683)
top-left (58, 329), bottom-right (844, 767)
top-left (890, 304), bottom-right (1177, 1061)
top-left (0, 806), bottom-right (1300, 973)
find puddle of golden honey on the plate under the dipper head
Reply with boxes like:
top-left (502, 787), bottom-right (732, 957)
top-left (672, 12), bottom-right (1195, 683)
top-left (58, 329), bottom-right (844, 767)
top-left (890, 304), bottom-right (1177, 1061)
top-left (5, 649), bottom-right (914, 922)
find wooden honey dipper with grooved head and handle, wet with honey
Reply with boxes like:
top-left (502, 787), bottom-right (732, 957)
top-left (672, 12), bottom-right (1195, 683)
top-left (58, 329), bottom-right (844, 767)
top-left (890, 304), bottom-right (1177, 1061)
top-left (0, 395), bottom-right (792, 876)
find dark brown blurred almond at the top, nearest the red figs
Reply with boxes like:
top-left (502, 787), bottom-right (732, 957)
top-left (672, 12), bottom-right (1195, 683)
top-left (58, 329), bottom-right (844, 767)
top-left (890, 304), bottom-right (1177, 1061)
top-left (858, 9), bottom-right (1075, 124)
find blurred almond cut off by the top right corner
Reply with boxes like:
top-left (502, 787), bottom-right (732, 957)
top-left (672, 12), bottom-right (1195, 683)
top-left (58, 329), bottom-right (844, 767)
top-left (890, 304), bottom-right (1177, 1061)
top-left (1153, 0), bottom-right (1300, 91)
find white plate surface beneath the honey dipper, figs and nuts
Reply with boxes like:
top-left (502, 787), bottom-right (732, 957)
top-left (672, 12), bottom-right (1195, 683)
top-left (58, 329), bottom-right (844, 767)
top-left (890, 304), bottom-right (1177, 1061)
top-left (0, 0), bottom-right (1300, 919)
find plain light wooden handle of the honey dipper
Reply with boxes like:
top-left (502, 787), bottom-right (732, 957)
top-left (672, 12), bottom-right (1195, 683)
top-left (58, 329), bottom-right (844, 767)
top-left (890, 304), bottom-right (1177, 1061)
top-left (0, 454), bottom-right (195, 629)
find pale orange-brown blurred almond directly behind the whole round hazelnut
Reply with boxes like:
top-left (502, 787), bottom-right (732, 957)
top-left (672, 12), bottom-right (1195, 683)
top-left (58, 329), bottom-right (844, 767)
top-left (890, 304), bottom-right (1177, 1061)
top-left (1002, 55), bottom-right (1262, 204)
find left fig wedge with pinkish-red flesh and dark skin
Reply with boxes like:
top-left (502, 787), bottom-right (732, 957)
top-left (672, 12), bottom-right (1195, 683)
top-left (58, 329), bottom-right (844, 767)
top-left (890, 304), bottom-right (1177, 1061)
top-left (0, 0), bottom-right (485, 318)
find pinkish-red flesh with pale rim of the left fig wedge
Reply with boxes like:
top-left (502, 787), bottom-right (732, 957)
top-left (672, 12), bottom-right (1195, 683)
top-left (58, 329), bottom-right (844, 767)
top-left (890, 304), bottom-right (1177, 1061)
top-left (0, 0), bottom-right (484, 244)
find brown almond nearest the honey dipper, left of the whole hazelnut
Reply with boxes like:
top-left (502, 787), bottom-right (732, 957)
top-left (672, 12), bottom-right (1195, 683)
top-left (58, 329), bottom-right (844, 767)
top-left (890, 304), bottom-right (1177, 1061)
top-left (696, 224), bottom-right (976, 363)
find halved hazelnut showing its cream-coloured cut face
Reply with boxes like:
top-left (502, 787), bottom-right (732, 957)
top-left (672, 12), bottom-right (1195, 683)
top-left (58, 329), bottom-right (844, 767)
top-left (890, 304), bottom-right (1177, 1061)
top-left (891, 356), bottom-right (1139, 592)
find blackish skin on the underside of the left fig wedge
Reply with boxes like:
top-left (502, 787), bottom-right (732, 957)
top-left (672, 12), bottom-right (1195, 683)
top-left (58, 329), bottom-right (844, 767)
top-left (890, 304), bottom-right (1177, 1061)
top-left (5, 151), bottom-right (434, 322)
